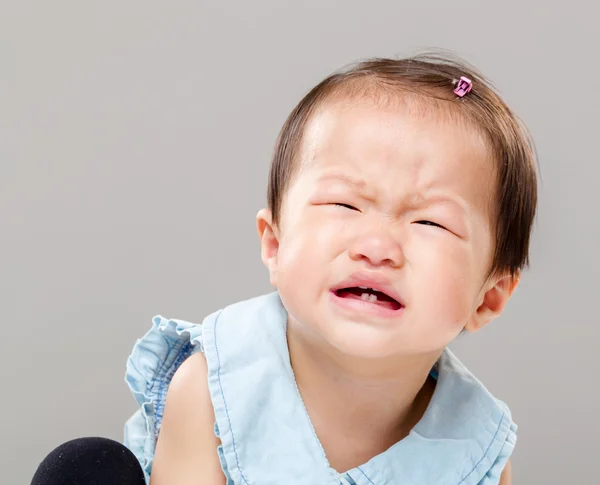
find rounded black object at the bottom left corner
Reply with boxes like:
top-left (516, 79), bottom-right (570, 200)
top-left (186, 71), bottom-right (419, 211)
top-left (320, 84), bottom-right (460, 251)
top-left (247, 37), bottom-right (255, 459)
top-left (31, 438), bottom-right (146, 485)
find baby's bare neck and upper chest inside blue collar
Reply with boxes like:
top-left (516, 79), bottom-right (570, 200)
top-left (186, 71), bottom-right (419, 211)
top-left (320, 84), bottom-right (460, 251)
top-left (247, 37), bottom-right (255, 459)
top-left (287, 322), bottom-right (441, 469)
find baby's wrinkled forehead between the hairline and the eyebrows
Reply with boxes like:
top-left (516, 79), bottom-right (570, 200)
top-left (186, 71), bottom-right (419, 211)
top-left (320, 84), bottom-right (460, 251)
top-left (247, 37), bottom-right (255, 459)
top-left (299, 100), bottom-right (495, 211)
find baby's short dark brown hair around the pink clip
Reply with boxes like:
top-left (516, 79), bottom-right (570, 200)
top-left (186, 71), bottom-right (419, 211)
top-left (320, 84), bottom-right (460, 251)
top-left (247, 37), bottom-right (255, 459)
top-left (267, 52), bottom-right (537, 276)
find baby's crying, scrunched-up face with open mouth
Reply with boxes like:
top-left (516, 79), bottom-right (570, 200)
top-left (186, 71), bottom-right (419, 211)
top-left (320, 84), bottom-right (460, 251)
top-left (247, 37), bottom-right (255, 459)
top-left (271, 97), bottom-right (502, 357)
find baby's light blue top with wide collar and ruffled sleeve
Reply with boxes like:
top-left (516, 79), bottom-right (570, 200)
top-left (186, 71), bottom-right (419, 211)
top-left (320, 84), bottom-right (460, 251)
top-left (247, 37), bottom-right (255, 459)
top-left (125, 293), bottom-right (517, 485)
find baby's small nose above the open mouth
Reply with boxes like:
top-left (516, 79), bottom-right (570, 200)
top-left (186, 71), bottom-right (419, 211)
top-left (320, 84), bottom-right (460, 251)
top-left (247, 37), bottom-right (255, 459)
top-left (349, 231), bottom-right (404, 268)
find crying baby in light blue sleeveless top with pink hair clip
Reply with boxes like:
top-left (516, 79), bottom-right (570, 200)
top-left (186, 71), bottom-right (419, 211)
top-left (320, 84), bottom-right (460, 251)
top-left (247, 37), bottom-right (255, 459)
top-left (125, 51), bottom-right (537, 485)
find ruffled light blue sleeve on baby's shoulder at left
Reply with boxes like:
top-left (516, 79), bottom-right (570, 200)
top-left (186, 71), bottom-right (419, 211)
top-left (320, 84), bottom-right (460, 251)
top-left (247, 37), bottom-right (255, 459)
top-left (124, 316), bottom-right (204, 483)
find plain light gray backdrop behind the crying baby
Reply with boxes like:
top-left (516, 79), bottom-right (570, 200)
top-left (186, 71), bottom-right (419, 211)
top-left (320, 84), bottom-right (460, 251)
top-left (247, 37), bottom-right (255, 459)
top-left (0, 0), bottom-right (600, 485)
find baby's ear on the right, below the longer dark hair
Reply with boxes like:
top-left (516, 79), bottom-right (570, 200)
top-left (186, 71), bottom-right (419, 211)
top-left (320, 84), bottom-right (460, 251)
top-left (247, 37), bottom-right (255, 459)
top-left (465, 274), bottom-right (521, 333)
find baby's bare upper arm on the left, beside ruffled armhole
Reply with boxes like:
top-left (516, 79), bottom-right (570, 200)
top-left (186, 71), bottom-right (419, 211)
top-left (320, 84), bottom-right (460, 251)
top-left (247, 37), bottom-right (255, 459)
top-left (150, 352), bottom-right (225, 485)
